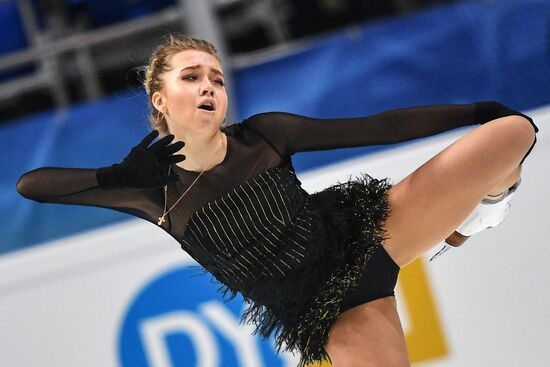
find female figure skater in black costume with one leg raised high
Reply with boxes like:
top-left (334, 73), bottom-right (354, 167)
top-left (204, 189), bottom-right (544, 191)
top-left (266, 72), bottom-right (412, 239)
top-left (17, 36), bottom-right (538, 367)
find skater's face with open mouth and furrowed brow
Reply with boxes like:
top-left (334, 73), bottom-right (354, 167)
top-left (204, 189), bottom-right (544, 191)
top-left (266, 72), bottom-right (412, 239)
top-left (152, 50), bottom-right (227, 132)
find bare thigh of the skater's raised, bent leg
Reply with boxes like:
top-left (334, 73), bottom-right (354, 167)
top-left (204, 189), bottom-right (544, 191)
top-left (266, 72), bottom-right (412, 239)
top-left (384, 116), bottom-right (534, 267)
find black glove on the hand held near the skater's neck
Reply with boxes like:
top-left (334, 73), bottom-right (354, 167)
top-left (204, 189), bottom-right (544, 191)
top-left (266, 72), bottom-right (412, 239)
top-left (96, 130), bottom-right (185, 189)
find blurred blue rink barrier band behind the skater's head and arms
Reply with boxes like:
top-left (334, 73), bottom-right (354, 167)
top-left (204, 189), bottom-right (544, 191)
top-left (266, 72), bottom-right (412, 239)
top-left (0, 0), bottom-right (550, 252)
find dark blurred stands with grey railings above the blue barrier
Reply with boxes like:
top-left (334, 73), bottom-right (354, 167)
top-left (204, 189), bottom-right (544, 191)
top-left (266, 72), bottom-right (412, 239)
top-left (0, 0), bottom-right (445, 121)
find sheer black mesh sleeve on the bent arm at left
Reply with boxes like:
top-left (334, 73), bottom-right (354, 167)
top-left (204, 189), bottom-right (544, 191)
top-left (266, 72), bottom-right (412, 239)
top-left (17, 167), bottom-right (160, 221)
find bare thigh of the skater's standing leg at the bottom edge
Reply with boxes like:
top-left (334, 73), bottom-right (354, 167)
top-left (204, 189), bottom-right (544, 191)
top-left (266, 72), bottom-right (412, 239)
top-left (325, 296), bottom-right (410, 367)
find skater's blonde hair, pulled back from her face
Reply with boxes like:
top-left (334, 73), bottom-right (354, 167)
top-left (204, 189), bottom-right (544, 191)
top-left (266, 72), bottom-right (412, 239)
top-left (143, 34), bottom-right (221, 134)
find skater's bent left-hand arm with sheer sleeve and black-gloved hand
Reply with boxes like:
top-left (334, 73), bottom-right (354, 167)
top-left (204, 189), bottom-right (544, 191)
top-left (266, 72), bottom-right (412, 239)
top-left (17, 131), bottom-right (185, 216)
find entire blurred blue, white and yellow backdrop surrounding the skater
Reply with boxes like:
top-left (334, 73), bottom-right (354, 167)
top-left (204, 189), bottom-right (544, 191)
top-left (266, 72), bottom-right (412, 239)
top-left (0, 0), bottom-right (550, 367)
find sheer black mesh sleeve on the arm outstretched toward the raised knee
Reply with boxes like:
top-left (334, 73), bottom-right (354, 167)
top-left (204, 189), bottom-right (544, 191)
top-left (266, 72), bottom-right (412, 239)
top-left (244, 104), bottom-right (480, 156)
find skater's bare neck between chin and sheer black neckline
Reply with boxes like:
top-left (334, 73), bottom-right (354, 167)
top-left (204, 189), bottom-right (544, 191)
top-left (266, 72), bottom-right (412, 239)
top-left (174, 130), bottom-right (226, 172)
